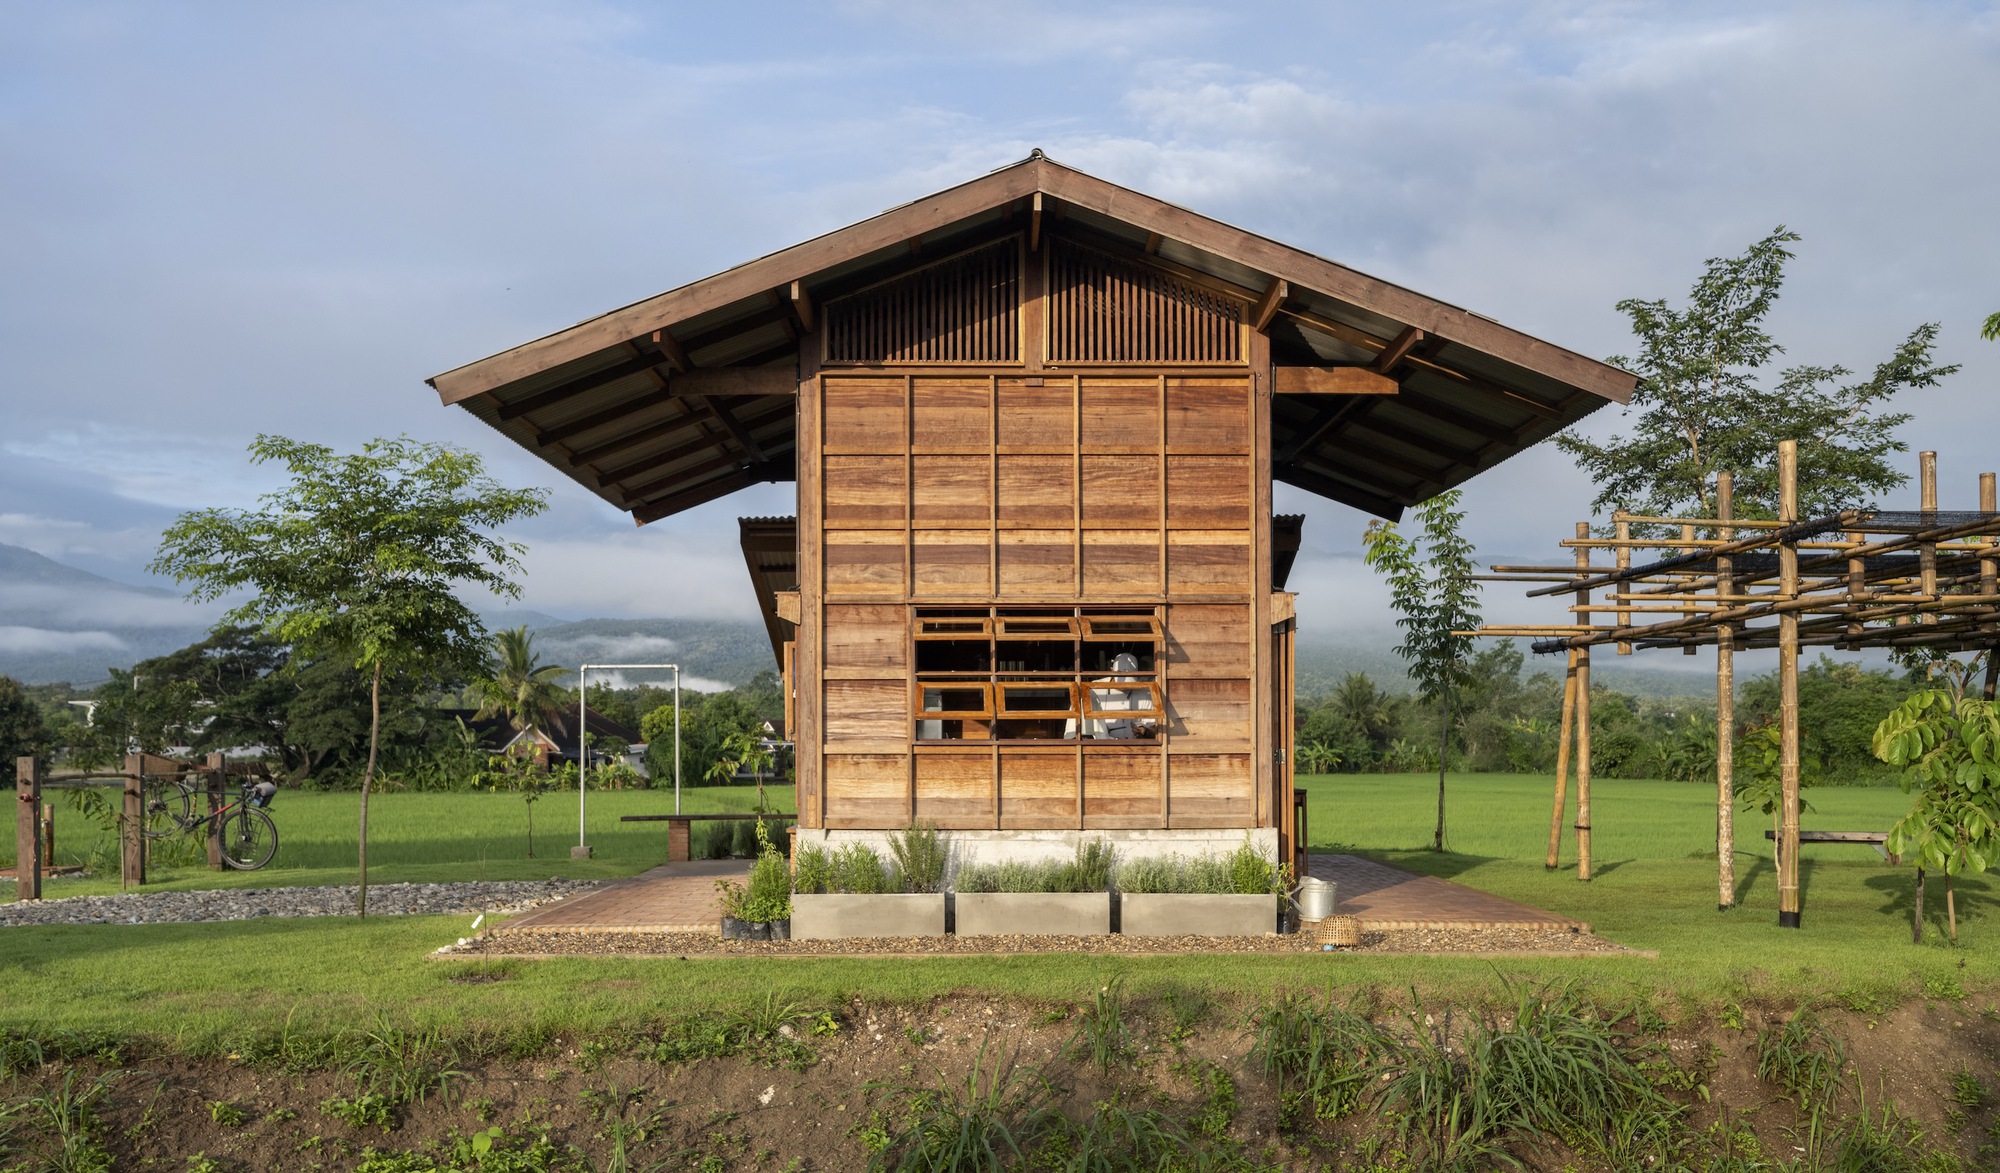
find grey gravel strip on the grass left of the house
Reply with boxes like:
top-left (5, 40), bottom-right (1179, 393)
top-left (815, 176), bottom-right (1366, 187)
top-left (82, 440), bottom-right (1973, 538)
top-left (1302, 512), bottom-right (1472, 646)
top-left (0, 879), bottom-right (598, 929)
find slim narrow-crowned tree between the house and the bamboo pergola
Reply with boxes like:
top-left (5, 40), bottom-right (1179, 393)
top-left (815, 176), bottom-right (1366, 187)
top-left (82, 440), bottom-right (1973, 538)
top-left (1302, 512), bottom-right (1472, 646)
top-left (1362, 488), bottom-right (1480, 851)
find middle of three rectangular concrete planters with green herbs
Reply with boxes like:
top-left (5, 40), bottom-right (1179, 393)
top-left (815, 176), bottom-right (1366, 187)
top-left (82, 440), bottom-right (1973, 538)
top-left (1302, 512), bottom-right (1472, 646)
top-left (958, 839), bottom-right (1116, 937)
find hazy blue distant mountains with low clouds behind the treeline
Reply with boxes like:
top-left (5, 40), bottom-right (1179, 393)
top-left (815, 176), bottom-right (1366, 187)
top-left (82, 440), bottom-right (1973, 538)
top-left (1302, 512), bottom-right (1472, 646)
top-left (0, 544), bottom-right (1714, 697)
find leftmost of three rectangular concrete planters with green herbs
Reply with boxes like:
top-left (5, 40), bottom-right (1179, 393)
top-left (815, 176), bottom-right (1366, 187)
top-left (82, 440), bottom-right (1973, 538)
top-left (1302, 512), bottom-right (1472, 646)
top-left (792, 825), bottom-right (948, 941)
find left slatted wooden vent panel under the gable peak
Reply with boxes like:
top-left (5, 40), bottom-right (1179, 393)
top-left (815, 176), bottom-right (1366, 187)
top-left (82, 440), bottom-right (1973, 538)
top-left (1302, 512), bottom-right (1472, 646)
top-left (826, 238), bottom-right (1020, 364)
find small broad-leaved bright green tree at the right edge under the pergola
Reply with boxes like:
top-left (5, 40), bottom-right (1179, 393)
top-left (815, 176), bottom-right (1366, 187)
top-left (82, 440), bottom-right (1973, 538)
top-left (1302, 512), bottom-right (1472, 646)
top-left (1874, 689), bottom-right (2000, 945)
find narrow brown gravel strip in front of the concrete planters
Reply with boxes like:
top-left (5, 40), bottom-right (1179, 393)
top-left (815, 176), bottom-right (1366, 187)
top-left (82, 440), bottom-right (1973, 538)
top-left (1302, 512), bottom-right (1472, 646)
top-left (434, 929), bottom-right (1640, 959)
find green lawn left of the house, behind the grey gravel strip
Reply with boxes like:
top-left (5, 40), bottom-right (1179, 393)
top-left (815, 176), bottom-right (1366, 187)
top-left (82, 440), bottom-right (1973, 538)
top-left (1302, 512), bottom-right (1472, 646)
top-left (0, 787), bottom-right (792, 901)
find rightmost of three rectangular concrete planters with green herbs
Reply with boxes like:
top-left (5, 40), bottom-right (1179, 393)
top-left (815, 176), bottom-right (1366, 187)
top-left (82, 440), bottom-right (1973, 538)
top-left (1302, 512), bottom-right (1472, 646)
top-left (1118, 841), bottom-right (1290, 937)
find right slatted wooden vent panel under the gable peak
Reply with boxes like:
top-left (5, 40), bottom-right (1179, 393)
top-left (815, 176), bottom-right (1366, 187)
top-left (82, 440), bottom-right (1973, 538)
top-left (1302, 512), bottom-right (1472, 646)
top-left (1048, 240), bottom-right (1244, 362)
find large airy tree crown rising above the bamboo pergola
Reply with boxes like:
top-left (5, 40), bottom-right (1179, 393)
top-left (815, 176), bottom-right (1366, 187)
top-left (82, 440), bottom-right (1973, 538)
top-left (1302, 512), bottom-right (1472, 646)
top-left (1556, 226), bottom-right (1958, 518)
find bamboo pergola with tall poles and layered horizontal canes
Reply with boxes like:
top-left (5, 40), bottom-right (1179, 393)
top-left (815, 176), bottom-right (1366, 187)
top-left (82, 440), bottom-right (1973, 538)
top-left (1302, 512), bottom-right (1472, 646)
top-left (1466, 440), bottom-right (2000, 929)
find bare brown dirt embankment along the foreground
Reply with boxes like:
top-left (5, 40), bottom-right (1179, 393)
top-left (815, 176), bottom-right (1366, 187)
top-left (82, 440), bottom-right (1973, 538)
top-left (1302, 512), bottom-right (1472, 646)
top-left (11, 991), bottom-right (2000, 1173)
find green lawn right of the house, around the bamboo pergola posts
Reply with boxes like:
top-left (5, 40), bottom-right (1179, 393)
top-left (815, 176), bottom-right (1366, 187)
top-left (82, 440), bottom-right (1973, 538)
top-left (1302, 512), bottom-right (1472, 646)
top-left (1304, 775), bottom-right (2000, 985)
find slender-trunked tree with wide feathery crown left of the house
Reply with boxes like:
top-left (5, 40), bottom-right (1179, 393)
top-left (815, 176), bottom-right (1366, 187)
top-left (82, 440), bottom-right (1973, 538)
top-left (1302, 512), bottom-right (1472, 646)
top-left (152, 436), bottom-right (546, 917)
